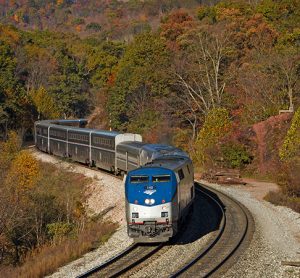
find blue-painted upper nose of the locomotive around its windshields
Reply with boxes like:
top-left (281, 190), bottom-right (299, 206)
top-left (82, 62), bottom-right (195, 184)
top-left (125, 167), bottom-right (177, 207)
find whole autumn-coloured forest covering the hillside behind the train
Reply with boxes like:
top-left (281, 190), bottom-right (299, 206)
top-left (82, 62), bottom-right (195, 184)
top-left (0, 0), bottom-right (300, 274)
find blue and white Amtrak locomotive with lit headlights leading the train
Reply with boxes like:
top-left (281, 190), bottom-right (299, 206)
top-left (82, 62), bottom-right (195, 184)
top-left (125, 155), bottom-right (195, 242)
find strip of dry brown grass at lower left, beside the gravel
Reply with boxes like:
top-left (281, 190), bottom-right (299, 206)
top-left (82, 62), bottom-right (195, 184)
top-left (0, 219), bottom-right (117, 278)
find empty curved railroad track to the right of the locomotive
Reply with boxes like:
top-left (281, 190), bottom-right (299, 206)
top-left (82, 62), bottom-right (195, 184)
top-left (170, 183), bottom-right (255, 277)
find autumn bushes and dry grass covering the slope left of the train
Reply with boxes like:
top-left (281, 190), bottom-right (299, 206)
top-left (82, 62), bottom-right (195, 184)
top-left (0, 133), bottom-right (117, 277)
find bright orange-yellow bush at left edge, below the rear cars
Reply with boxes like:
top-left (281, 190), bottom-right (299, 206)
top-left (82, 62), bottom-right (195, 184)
top-left (6, 151), bottom-right (40, 192)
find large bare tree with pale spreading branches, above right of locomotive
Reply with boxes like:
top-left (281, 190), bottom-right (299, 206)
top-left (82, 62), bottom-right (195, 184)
top-left (173, 25), bottom-right (230, 138)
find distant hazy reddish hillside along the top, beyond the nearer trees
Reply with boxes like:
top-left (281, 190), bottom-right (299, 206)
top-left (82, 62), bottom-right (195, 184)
top-left (0, 0), bottom-right (211, 39)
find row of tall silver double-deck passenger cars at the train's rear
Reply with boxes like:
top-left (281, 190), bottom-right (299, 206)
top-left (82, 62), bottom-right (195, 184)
top-left (35, 120), bottom-right (142, 172)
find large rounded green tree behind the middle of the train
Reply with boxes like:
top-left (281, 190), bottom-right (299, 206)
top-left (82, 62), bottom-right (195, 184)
top-left (108, 32), bottom-right (169, 130)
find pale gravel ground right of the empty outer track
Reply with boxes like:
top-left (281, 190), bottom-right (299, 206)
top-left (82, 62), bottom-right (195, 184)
top-left (202, 181), bottom-right (300, 278)
